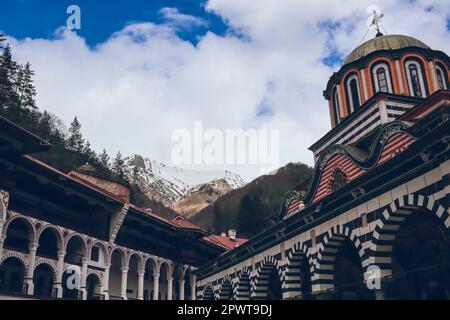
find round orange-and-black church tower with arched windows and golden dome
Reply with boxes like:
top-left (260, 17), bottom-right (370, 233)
top-left (310, 32), bottom-right (450, 159)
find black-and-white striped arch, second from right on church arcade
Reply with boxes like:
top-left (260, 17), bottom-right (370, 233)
top-left (311, 225), bottom-right (366, 292)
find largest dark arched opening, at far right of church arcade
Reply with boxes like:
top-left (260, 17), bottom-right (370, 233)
top-left (386, 209), bottom-right (450, 300)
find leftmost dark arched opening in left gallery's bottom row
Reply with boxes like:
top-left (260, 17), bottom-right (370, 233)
top-left (0, 257), bottom-right (25, 293)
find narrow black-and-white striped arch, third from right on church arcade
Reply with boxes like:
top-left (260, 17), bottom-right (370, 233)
top-left (283, 242), bottom-right (314, 299)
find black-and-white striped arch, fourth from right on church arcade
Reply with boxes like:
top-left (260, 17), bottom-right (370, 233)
top-left (250, 256), bottom-right (284, 300)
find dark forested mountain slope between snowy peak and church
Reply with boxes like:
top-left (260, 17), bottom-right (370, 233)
top-left (190, 163), bottom-right (313, 237)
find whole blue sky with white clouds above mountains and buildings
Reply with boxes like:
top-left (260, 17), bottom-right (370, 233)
top-left (0, 0), bottom-right (450, 180)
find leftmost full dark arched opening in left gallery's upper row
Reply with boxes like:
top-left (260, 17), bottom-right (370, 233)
top-left (3, 218), bottom-right (33, 253)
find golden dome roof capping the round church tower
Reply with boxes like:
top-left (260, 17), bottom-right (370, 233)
top-left (344, 35), bottom-right (430, 64)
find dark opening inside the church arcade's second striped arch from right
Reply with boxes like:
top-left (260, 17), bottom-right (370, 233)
top-left (334, 238), bottom-right (373, 300)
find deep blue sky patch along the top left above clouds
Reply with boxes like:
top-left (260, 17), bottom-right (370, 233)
top-left (0, 0), bottom-right (227, 46)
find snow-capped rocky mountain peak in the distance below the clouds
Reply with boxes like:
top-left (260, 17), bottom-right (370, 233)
top-left (125, 154), bottom-right (246, 214)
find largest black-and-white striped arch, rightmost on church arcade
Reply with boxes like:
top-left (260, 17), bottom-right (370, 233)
top-left (367, 194), bottom-right (450, 278)
